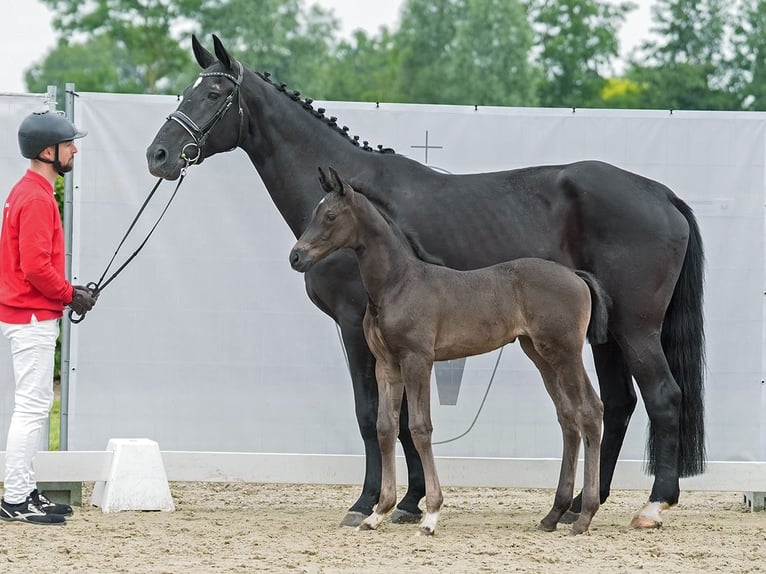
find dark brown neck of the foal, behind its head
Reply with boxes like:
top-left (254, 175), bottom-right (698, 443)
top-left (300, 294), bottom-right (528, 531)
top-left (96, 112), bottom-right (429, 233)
top-left (356, 197), bottom-right (425, 304)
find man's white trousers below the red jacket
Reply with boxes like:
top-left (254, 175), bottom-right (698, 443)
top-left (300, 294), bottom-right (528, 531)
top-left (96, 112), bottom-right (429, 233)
top-left (0, 316), bottom-right (59, 504)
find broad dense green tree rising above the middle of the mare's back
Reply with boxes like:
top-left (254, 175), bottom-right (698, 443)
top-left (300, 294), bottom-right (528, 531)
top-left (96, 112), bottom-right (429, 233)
top-left (395, 0), bottom-right (535, 105)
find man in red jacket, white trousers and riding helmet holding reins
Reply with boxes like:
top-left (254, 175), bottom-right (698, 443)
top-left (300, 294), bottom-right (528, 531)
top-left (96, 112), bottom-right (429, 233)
top-left (0, 111), bottom-right (96, 524)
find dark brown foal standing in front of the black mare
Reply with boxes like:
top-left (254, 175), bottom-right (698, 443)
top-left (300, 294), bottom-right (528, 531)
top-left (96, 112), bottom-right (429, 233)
top-left (290, 168), bottom-right (608, 534)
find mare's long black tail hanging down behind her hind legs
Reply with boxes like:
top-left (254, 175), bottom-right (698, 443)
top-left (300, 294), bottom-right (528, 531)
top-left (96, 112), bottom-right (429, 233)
top-left (647, 200), bottom-right (705, 477)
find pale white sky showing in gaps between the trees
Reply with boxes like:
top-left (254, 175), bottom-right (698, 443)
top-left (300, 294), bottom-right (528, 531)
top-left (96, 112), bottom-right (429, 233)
top-left (0, 0), bottom-right (652, 92)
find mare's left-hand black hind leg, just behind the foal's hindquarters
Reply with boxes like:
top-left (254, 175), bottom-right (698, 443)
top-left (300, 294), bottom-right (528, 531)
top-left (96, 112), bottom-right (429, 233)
top-left (561, 338), bottom-right (636, 523)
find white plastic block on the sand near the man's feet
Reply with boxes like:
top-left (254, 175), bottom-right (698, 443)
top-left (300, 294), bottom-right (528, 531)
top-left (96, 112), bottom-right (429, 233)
top-left (91, 438), bottom-right (175, 513)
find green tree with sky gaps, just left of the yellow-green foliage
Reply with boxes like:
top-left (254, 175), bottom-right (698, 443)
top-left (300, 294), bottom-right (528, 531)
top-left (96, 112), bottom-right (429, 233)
top-left (530, 0), bottom-right (636, 107)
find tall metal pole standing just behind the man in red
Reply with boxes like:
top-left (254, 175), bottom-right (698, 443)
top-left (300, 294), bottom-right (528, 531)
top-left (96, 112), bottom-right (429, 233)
top-left (59, 84), bottom-right (75, 450)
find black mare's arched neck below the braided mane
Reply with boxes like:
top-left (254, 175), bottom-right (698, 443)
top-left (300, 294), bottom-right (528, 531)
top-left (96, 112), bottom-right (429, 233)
top-left (242, 73), bottom-right (370, 237)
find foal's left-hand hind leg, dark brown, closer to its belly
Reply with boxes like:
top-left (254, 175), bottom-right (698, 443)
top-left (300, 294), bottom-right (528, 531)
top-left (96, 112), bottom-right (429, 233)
top-left (519, 337), bottom-right (580, 532)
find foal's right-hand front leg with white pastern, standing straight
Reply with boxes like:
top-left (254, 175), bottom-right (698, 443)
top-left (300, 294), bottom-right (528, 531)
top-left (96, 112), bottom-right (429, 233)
top-left (401, 354), bottom-right (444, 535)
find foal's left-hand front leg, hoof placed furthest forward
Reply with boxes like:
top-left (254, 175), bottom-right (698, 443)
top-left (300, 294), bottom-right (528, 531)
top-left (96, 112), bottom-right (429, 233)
top-left (359, 360), bottom-right (404, 530)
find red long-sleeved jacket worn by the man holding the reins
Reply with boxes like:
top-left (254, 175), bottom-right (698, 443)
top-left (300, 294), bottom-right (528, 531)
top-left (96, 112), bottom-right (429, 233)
top-left (0, 170), bottom-right (73, 324)
